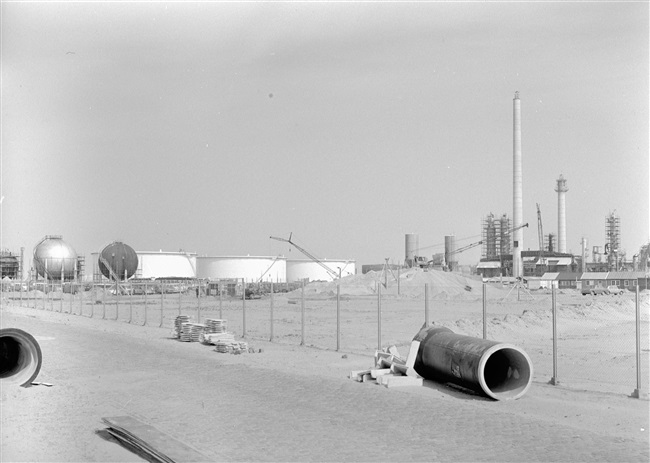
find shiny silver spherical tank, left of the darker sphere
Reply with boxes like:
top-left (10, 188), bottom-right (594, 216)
top-left (34, 236), bottom-right (77, 281)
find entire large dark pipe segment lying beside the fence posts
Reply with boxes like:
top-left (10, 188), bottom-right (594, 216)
top-left (414, 326), bottom-right (533, 400)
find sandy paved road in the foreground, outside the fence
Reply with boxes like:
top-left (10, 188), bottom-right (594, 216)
top-left (1, 311), bottom-right (650, 462)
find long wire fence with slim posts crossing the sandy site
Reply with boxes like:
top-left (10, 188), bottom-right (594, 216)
top-left (3, 279), bottom-right (650, 394)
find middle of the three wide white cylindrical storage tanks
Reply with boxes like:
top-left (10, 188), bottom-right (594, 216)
top-left (196, 256), bottom-right (287, 283)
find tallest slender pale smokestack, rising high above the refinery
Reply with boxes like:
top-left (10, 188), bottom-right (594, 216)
top-left (512, 92), bottom-right (524, 278)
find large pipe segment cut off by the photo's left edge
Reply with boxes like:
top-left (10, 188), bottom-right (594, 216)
top-left (0, 328), bottom-right (43, 386)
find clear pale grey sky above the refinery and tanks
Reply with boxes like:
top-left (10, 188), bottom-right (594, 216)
top-left (0, 1), bottom-right (650, 269)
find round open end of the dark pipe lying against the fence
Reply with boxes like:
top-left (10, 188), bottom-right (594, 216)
top-left (480, 346), bottom-right (532, 400)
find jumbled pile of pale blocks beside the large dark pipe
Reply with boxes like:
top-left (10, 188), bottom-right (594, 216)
top-left (350, 341), bottom-right (423, 387)
